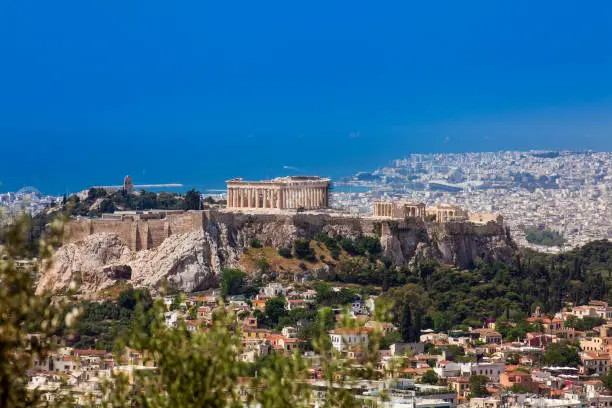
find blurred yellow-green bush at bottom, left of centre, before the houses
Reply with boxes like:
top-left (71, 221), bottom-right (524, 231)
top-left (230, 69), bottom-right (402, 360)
top-left (103, 302), bottom-right (309, 408)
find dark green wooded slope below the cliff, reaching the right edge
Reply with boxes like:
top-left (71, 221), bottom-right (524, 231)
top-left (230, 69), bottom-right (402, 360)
top-left (241, 236), bottom-right (612, 330)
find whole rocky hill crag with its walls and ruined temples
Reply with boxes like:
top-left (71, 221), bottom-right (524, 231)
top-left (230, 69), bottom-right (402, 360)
top-left (39, 179), bottom-right (514, 291)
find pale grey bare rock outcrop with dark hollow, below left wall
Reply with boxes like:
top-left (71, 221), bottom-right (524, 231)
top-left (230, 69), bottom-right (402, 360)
top-left (37, 232), bottom-right (220, 294)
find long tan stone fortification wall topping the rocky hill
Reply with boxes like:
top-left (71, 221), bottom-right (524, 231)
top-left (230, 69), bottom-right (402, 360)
top-left (63, 210), bottom-right (513, 266)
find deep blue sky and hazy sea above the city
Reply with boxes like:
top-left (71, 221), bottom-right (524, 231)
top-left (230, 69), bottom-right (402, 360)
top-left (0, 0), bottom-right (612, 193)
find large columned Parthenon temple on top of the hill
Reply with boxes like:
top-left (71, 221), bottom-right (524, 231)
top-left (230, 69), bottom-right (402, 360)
top-left (227, 176), bottom-right (330, 210)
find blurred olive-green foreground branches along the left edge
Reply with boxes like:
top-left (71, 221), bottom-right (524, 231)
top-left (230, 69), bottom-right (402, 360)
top-left (0, 217), bottom-right (72, 407)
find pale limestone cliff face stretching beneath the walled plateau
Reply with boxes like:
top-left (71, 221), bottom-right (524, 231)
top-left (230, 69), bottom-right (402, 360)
top-left (38, 211), bottom-right (514, 293)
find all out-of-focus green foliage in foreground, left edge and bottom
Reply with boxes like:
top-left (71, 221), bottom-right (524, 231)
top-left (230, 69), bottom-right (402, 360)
top-left (0, 215), bottom-right (392, 407)
